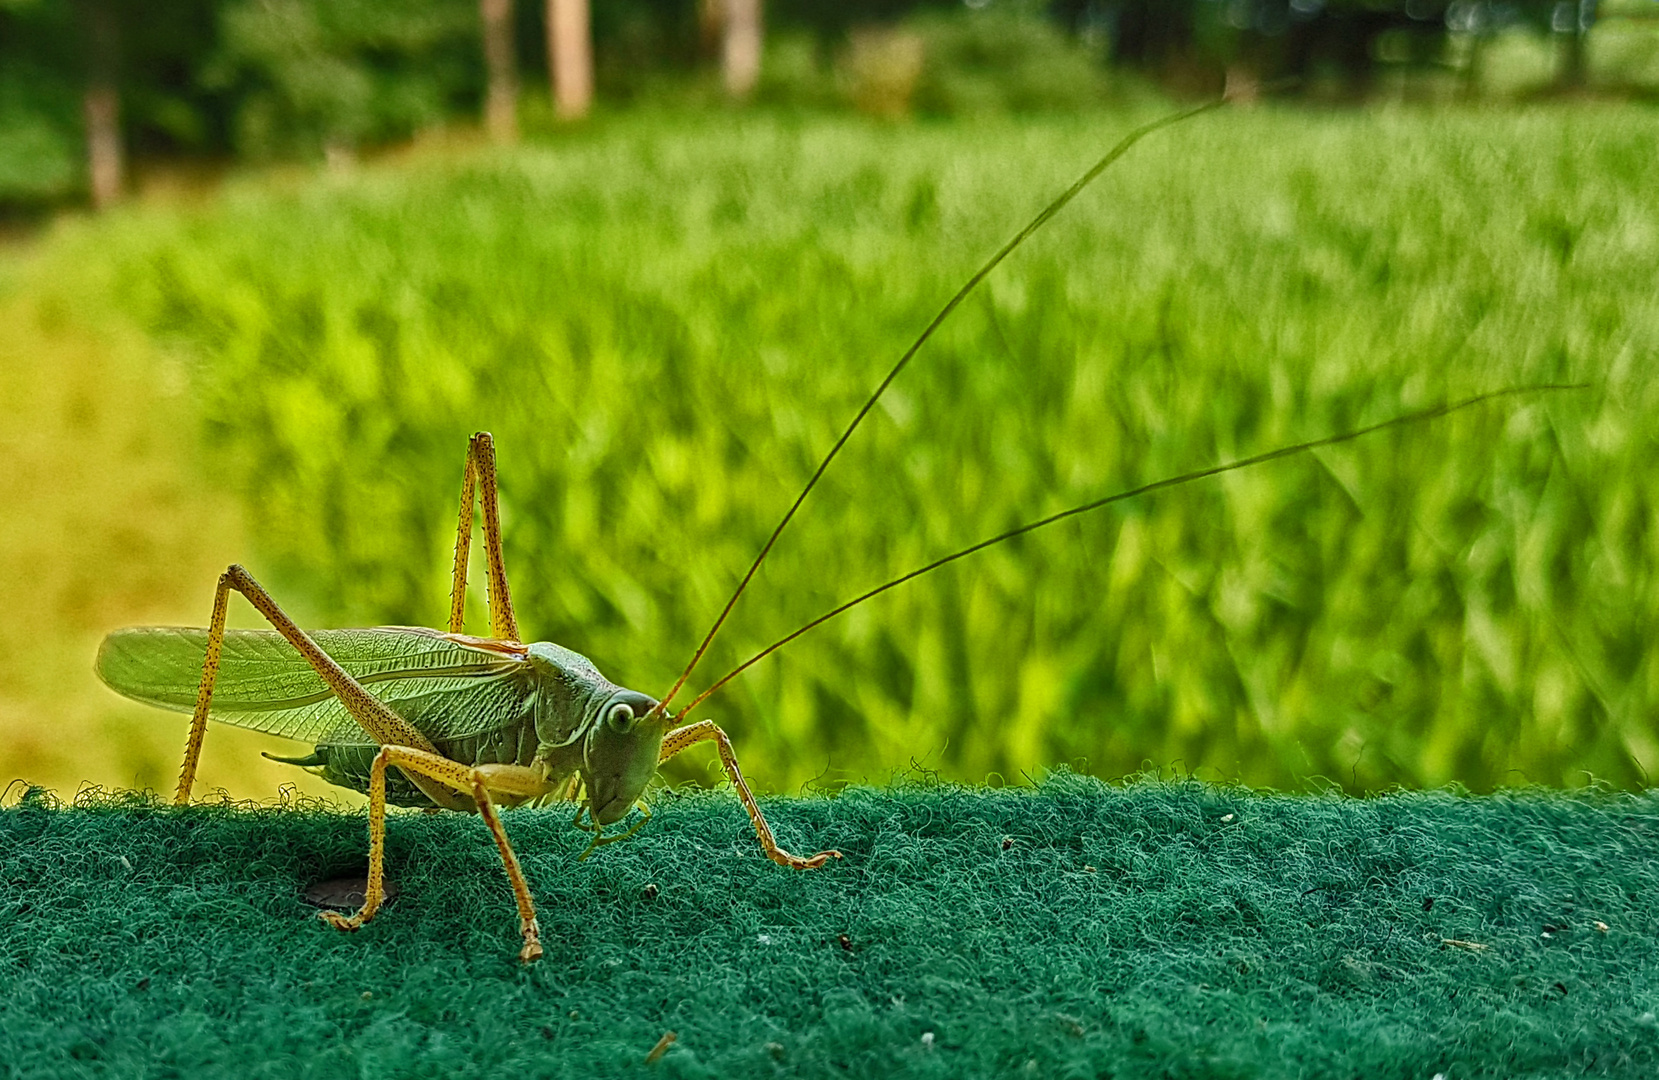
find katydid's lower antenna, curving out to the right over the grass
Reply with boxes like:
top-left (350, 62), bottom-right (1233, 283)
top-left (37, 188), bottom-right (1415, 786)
top-left (680, 383), bottom-right (1589, 715)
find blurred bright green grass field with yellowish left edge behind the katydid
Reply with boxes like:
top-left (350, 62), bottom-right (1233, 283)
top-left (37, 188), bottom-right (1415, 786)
top-left (0, 106), bottom-right (1659, 795)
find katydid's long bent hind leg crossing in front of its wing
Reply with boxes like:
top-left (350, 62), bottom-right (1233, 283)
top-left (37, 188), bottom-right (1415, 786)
top-left (173, 564), bottom-right (466, 810)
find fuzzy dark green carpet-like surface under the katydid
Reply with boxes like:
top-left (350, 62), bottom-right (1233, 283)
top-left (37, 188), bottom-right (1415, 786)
top-left (0, 775), bottom-right (1659, 1080)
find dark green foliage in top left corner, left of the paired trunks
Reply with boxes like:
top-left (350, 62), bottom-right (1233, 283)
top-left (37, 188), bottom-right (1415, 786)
top-left (0, 0), bottom-right (481, 207)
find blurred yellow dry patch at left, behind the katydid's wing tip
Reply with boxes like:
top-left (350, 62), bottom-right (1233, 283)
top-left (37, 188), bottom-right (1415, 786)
top-left (0, 290), bottom-right (360, 798)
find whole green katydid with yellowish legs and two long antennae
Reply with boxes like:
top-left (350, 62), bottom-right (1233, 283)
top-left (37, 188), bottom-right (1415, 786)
top-left (96, 101), bottom-right (1579, 961)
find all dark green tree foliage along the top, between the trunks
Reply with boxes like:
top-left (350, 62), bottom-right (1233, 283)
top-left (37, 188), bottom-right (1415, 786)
top-left (0, 0), bottom-right (1596, 209)
